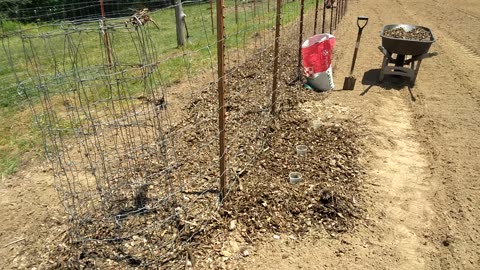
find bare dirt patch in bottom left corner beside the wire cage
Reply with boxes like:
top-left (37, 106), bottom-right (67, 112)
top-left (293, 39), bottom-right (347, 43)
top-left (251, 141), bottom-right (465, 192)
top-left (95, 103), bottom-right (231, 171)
top-left (0, 165), bottom-right (66, 269)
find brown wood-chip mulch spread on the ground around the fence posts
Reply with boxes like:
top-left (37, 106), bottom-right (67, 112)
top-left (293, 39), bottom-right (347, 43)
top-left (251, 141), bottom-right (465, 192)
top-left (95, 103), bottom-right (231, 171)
top-left (44, 39), bottom-right (362, 269)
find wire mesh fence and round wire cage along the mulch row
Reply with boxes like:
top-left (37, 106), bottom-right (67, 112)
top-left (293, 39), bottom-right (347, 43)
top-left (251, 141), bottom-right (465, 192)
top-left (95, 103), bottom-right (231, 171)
top-left (0, 0), bottom-right (354, 269)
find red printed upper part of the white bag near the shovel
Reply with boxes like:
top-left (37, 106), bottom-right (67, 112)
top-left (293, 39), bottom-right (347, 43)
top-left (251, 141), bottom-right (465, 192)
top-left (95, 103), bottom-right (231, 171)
top-left (302, 34), bottom-right (335, 77)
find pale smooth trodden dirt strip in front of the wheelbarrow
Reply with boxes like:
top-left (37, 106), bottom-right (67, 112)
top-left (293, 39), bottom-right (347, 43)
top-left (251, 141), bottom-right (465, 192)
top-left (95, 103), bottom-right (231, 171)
top-left (364, 96), bottom-right (434, 269)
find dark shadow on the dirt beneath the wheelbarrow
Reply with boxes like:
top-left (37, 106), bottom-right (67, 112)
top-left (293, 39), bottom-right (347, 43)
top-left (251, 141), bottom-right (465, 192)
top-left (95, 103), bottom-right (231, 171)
top-left (360, 68), bottom-right (416, 101)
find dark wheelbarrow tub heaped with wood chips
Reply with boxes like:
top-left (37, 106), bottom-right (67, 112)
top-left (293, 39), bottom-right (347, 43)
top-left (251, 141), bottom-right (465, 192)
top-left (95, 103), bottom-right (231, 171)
top-left (380, 24), bottom-right (435, 55)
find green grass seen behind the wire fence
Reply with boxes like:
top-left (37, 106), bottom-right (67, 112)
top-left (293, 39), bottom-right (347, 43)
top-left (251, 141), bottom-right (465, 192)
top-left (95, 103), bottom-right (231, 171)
top-left (0, 0), bottom-right (315, 174)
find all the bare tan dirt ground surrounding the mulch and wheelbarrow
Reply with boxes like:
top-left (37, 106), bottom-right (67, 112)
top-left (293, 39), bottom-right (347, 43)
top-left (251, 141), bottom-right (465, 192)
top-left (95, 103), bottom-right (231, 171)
top-left (0, 0), bottom-right (480, 269)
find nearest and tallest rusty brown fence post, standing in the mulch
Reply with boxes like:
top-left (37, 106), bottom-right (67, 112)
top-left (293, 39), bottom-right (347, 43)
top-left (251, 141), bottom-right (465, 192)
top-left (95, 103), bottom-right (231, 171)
top-left (217, 0), bottom-right (227, 203)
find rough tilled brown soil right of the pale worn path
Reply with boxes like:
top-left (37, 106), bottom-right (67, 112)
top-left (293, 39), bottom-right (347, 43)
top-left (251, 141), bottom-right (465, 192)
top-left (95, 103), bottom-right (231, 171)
top-left (396, 0), bottom-right (480, 269)
